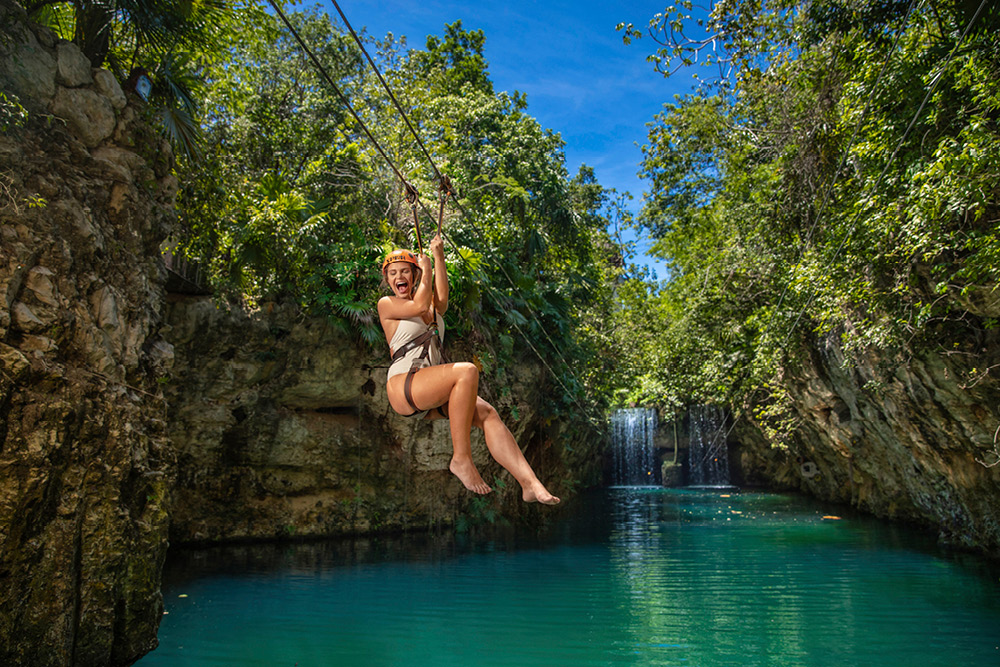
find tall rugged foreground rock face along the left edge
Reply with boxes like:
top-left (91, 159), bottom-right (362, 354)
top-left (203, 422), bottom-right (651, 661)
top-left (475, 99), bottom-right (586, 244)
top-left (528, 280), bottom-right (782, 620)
top-left (0, 9), bottom-right (176, 667)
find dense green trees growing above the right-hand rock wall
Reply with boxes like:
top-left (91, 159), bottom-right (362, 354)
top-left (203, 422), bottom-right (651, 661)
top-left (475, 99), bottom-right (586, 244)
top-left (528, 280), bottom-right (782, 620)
top-left (615, 0), bottom-right (1000, 436)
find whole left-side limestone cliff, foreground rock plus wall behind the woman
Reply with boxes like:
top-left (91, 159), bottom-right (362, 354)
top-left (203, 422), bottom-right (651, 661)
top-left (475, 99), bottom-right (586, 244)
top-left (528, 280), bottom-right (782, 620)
top-left (0, 3), bottom-right (600, 667)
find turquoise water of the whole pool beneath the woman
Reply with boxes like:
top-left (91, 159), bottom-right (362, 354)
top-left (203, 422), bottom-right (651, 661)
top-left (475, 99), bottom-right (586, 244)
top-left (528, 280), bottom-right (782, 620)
top-left (137, 488), bottom-right (1000, 667)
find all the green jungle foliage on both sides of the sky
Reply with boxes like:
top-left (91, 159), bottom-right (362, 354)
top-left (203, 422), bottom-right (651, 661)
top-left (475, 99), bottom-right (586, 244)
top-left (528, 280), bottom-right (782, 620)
top-left (29, 0), bottom-right (1000, 435)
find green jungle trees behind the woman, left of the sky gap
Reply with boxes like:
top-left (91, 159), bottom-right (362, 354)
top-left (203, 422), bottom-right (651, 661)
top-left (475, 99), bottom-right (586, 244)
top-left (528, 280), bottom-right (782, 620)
top-left (137, 6), bottom-right (621, 416)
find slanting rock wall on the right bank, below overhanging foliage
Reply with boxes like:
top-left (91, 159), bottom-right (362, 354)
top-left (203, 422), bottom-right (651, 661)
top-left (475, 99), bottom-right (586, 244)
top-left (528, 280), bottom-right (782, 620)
top-left (730, 316), bottom-right (1000, 557)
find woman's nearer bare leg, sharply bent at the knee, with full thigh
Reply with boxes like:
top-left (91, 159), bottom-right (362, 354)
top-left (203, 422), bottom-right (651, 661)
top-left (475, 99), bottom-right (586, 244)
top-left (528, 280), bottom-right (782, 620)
top-left (386, 362), bottom-right (492, 494)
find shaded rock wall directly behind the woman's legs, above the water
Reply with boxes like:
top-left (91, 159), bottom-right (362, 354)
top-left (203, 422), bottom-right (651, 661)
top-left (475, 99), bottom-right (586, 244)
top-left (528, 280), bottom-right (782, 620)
top-left (166, 295), bottom-right (600, 543)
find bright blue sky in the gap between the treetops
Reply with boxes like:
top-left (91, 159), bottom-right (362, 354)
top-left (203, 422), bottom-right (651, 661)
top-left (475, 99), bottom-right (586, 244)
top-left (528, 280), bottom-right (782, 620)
top-left (321, 0), bottom-right (693, 278)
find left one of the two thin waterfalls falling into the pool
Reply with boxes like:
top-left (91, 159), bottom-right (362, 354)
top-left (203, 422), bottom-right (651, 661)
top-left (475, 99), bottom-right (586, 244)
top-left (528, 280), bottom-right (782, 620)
top-left (611, 408), bottom-right (659, 486)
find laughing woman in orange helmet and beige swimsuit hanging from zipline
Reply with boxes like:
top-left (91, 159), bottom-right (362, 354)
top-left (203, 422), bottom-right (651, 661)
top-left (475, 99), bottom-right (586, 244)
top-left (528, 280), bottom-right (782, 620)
top-left (378, 182), bottom-right (559, 505)
